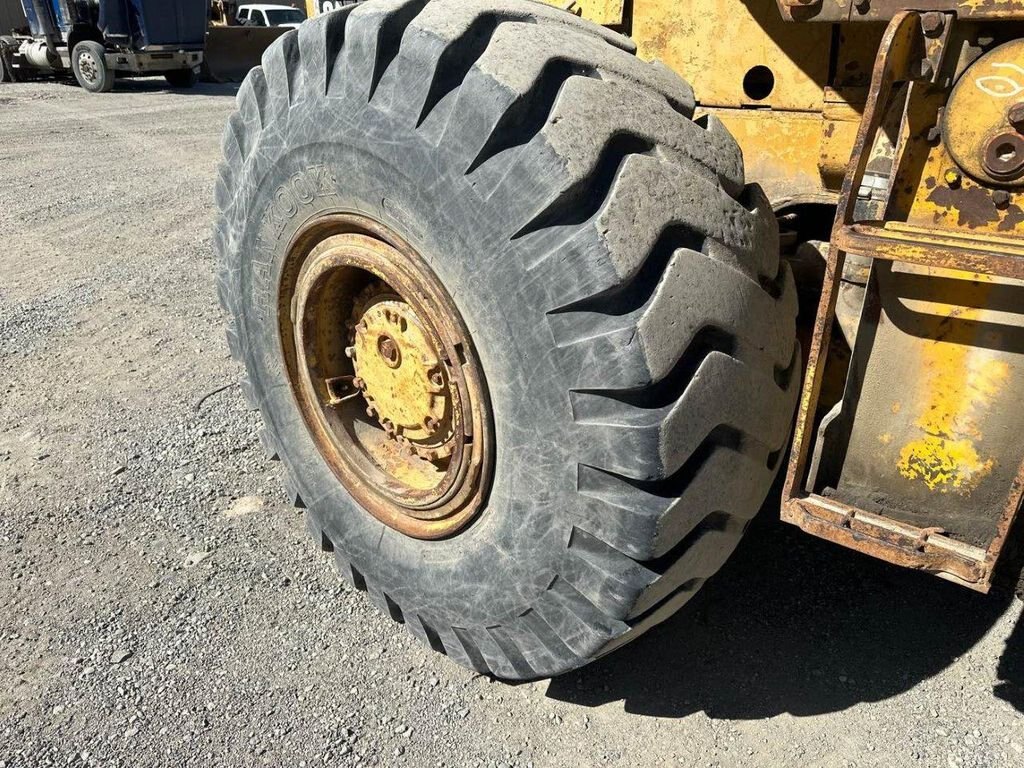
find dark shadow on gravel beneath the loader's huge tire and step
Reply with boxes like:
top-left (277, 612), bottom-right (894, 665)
top-left (548, 501), bottom-right (1024, 720)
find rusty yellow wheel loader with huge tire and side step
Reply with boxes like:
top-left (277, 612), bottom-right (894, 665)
top-left (215, 0), bottom-right (1024, 679)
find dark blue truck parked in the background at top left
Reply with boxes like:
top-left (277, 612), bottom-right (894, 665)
top-left (0, 0), bottom-right (210, 92)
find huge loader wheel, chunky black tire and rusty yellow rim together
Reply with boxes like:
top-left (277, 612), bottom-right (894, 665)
top-left (214, 0), bottom-right (800, 679)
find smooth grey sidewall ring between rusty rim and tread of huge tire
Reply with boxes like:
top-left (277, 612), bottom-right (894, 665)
top-left (229, 97), bottom-right (582, 626)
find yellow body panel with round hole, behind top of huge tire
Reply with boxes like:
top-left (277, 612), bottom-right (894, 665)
top-left (547, 0), bottom-right (864, 207)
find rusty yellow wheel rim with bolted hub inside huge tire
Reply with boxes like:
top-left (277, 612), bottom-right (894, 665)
top-left (279, 215), bottom-right (494, 539)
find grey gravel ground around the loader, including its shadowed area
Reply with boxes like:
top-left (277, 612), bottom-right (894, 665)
top-left (0, 80), bottom-right (1024, 768)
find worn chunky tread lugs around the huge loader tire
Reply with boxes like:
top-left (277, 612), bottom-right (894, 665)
top-left (214, 0), bottom-right (800, 679)
